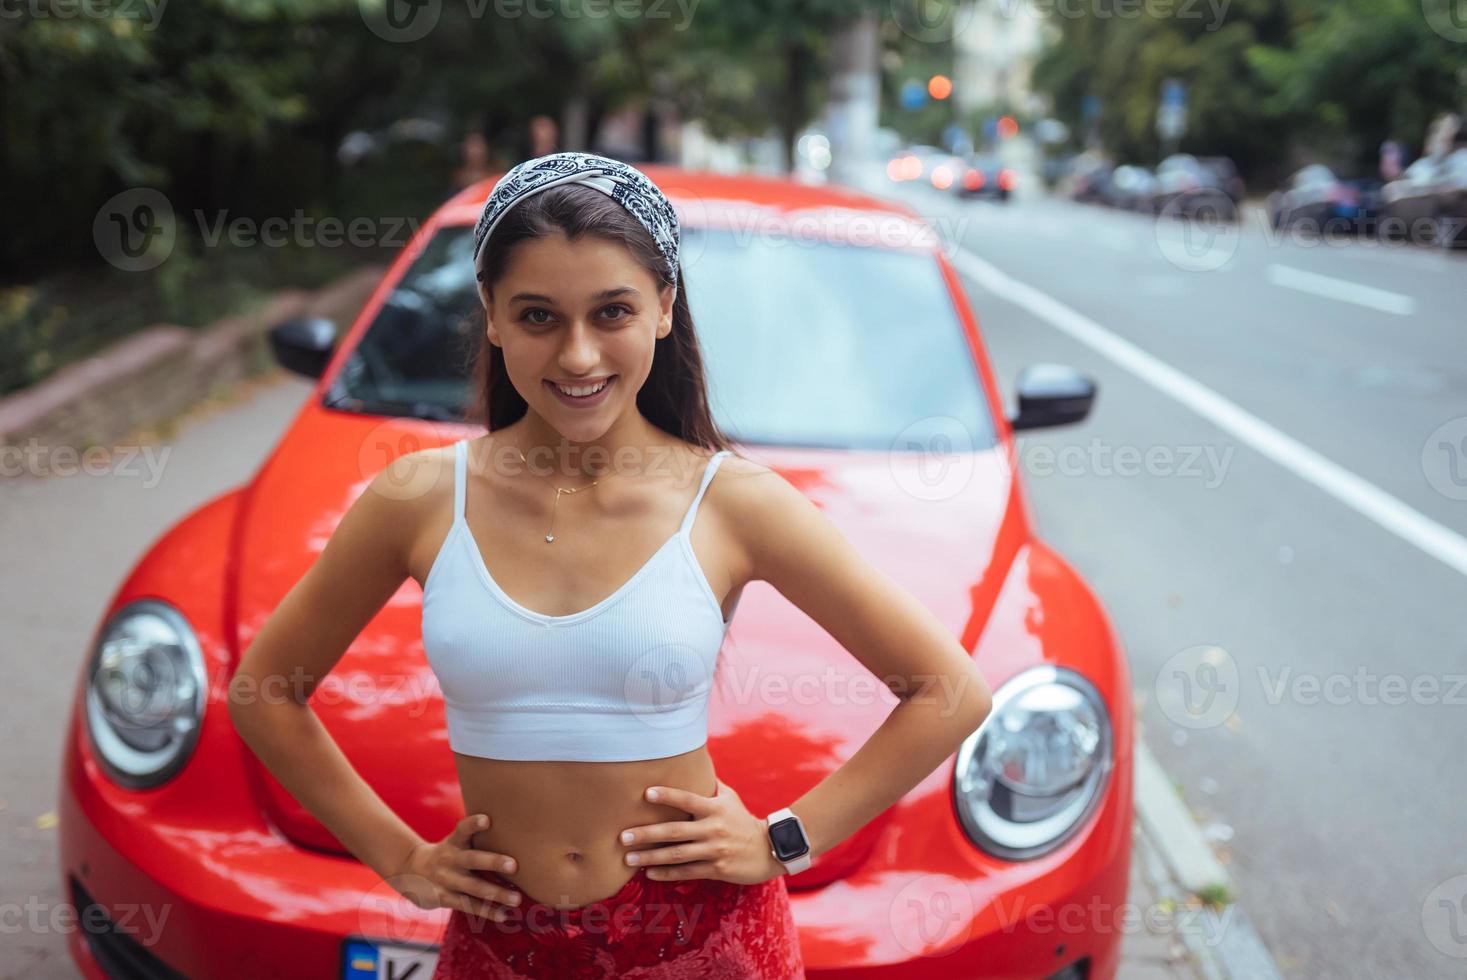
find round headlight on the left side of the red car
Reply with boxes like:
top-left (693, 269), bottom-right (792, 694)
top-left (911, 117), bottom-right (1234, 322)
top-left (87, 599), bottom-right (207, 789)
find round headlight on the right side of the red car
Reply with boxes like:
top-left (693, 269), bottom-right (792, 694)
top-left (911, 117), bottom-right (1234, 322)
top-left (952, 665), bottom-right (1112, 860)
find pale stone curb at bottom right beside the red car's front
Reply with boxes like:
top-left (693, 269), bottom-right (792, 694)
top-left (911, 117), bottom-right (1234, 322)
top-left (1133, 738), bottom-right (1281, 980)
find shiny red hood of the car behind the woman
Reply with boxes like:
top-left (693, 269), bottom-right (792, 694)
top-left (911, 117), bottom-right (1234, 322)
top-left (235, 409), bottom-right (1022, 888)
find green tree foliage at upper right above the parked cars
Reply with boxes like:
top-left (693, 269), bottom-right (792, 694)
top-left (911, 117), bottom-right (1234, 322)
top-left (1034, 0), bottom-right (1467, 182)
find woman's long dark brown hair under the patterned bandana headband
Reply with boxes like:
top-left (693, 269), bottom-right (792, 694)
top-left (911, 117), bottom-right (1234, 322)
top-left (472, 183), bottom-right (734, 450)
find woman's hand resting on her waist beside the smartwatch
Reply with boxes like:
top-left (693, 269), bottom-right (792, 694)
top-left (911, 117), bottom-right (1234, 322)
top-left (619, 776), bottom-right (785, 885)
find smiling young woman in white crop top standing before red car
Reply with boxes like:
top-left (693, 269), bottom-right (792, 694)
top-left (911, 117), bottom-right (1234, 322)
top-left (232, 153), bottom-right (990, 980)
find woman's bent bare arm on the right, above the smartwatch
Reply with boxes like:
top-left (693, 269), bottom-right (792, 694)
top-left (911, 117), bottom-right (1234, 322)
top-left (726, 461), bottom-right (993, 857)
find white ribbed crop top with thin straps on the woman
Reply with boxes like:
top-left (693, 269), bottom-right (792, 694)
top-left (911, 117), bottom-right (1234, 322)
top-left (422, 440), bottom-right (738, 761)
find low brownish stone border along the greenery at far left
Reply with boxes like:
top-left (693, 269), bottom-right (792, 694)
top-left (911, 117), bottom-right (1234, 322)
top-left (0, 264), bottom-right (384, 450)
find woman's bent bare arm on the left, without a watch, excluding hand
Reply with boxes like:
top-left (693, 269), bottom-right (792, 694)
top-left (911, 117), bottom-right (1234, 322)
top-left (229, 450), bottom-right (442, 877)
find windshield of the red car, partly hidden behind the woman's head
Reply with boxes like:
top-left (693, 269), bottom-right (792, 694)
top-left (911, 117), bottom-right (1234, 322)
top-left (326, 224), bottom-right (995, 450)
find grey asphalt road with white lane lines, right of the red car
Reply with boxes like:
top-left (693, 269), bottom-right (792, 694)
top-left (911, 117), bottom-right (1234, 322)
top-left (885, 185), bottom-right (1467, 979)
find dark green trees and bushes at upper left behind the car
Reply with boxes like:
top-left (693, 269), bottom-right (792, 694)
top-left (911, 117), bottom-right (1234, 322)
top-left (0, 0), bottom-right (885, 393)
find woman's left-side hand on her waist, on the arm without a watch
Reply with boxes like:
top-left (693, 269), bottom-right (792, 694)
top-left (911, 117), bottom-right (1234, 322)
top-left (387, 813), bottom-right (522, 921)
